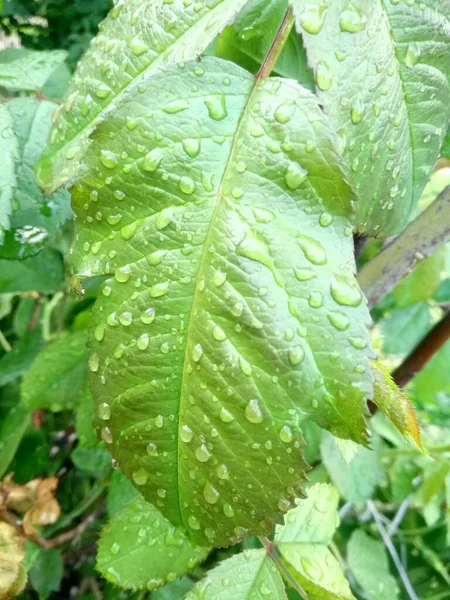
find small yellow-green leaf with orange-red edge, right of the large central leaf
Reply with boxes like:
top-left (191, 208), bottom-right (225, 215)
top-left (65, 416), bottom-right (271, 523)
top-left (372, 361), bottom-right (422, 448)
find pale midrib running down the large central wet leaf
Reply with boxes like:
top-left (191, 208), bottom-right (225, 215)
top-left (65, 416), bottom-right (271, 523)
top-left (176, 71), bottom-right (263, 521)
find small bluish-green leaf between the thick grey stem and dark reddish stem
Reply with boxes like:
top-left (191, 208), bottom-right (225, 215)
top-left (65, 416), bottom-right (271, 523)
top-left (381, 302), bottom-right (430, 354)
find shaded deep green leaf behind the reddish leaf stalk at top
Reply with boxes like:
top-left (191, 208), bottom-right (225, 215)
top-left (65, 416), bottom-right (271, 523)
top-left (214, 0), bottom-right (314, 85)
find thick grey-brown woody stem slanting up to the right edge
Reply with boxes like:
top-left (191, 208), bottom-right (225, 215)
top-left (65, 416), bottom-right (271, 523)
top-left (358, 186), bottom-right (450, 308)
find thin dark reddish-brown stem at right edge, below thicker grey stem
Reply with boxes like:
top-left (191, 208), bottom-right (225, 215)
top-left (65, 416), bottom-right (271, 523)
top-left (392, 313), bottom-right (450, 387)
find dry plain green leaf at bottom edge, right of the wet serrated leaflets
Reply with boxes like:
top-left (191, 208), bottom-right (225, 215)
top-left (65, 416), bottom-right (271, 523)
top-left (347, 529), bottom-right (399, 600)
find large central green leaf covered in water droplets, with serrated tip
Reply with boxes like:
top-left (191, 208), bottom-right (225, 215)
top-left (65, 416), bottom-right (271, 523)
top-left (69, 58), bottom-right (372, 545)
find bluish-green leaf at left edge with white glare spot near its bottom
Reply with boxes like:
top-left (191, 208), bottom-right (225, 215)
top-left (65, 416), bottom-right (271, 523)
top-left (0, 98), bottom-right (71, 258)
